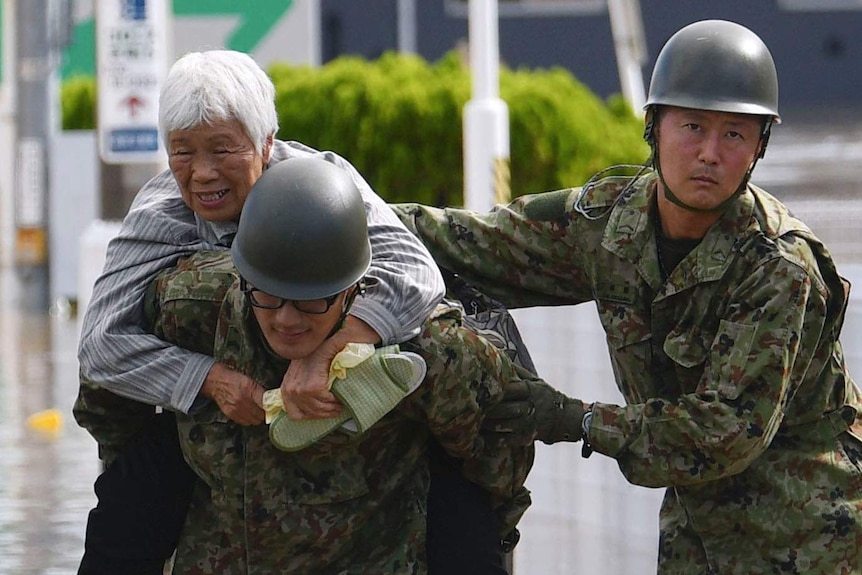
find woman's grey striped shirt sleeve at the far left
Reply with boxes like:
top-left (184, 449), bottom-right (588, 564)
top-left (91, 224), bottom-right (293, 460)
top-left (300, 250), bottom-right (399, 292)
top-left (78, 171), bottom-right (215, 412)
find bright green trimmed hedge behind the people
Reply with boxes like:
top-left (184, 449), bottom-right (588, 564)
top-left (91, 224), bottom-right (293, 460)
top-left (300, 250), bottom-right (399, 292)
top-left (63, 52), bottom-right (649, 205)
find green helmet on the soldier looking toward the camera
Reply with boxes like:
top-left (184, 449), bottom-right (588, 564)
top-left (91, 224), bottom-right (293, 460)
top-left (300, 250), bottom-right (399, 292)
top-left (644, 20), bottom-right (781, 123)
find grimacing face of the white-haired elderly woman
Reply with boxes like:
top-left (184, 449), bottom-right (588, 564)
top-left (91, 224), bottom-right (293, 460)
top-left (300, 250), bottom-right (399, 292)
top-left (168, 120), bottom-right (269, 222)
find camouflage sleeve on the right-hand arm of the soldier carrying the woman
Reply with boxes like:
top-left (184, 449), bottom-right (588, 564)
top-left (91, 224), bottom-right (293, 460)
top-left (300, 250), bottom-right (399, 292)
top-left (402, 312), bottom-right (534, 535)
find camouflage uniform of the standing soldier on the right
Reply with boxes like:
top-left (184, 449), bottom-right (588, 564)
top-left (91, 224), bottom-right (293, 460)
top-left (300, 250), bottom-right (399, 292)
top-left (395, 169), bottom-right (862, 575)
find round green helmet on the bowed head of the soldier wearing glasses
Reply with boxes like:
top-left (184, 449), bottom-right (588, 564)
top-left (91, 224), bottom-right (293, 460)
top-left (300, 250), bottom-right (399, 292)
top-left (231, 157), bottom-right (371, 300)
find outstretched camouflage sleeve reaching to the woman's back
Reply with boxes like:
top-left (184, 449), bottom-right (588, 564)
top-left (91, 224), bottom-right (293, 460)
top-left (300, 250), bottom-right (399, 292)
top-left (392, 190), bottom-right (591, 308)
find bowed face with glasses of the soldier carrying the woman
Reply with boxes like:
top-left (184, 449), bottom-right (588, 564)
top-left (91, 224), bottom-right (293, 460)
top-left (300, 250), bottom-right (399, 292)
top-left (252, 292), bottom-right (346, 359)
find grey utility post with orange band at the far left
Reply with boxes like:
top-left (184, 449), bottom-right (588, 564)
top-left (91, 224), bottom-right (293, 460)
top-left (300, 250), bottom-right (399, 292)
top-left (14, 0), bottom-right (52, 311)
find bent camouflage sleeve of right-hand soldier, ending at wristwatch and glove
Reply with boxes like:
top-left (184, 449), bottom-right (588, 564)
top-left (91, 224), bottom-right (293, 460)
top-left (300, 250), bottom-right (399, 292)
top-left (589, 254), bottom-right (827, 487)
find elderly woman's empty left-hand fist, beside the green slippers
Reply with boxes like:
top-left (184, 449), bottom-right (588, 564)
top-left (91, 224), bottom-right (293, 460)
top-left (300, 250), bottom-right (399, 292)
top-left (201, 363), bottom-right (265, 425)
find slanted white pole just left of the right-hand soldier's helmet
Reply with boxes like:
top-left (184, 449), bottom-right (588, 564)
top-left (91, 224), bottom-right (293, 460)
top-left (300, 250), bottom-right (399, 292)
top-left (608, 0), bottom-right (646, 114)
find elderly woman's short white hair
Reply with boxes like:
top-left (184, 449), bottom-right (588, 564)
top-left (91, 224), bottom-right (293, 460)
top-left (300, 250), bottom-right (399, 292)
top-left (159, 50), bottom-right (278, 154)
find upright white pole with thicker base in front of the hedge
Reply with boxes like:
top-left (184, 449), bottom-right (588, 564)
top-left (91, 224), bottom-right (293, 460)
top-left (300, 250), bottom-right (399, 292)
top-left (463, 0), bottom-right (509, 211)
